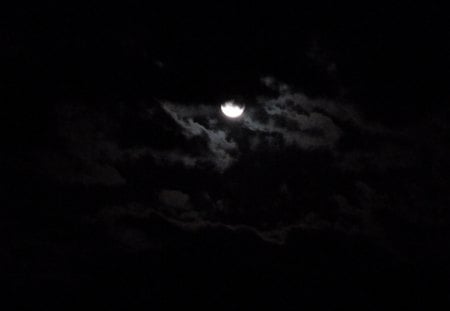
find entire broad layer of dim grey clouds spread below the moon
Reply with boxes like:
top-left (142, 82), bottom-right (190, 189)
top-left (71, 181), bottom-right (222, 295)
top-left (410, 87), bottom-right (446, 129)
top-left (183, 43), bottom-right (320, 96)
top-left (28, 78), bottom-right (448, 251)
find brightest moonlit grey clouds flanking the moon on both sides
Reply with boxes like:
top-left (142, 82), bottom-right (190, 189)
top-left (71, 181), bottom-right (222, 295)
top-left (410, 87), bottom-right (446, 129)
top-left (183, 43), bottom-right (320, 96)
top-left (155, 77), bottom-right (362, 172)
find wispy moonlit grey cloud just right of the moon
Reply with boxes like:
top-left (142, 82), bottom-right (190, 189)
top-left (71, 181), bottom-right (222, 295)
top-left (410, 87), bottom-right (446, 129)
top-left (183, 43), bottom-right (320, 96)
top-left (239, 77), bottom-right (387, 150)
